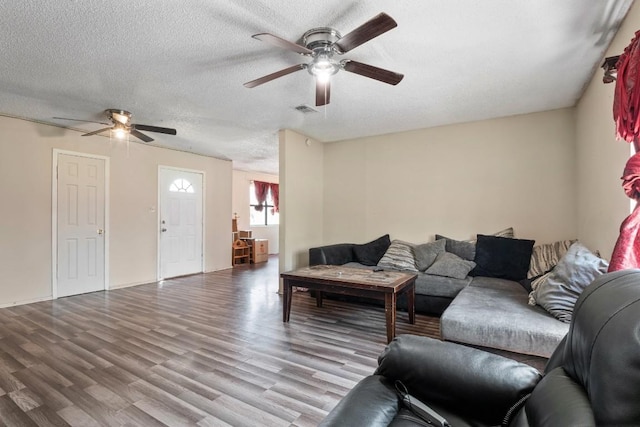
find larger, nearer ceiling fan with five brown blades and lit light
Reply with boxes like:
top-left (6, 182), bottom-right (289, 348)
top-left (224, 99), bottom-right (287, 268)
top-left (244, 12), bottom-right (404, 106)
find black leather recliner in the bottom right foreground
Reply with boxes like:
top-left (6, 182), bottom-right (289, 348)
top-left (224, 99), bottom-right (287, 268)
top-left (321, 270), bottom-right (640, 427)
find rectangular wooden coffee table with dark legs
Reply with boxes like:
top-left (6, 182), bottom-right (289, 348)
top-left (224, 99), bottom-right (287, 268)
top-left (280, 265), bottom-right (418, 342)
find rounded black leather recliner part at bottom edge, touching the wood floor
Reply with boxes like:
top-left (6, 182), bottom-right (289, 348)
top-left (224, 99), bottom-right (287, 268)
top-left (320, 375), bottom-right (399, 427)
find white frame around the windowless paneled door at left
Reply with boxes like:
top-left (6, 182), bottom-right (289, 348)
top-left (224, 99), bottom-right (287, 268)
top-left (51, 148), bottom-right (111, 299)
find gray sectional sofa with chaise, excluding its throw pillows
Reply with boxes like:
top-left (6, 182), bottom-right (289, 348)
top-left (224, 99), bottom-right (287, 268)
top-left (309, 237), bottom-right (569, 357)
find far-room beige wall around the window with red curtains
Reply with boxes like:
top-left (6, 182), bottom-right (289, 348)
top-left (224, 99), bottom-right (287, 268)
top-left (232, 170), bottom-right (280, 254)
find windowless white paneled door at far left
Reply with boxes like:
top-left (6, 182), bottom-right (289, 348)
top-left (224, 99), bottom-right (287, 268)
top-left (53, 154), bottom-right (106, 297)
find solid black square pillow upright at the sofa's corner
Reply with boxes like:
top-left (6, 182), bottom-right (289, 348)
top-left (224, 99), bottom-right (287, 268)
top-left (471, 234), bottom-right (535, 281)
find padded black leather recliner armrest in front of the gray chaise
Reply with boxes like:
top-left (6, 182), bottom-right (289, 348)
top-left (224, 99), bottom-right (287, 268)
top-left (376, 335), bottom-right (542, 424)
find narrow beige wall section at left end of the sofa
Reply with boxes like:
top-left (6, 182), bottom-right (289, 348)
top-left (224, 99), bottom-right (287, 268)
top-left (279, 130), bottom-right (324, 271)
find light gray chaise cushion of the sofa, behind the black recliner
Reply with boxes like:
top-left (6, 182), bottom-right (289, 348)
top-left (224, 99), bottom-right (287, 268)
top-left (440, 277), bottom-right (569, 357)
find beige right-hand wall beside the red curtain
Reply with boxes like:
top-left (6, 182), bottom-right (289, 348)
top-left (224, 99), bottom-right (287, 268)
top-left (576, 2), bottom-right (640, 259)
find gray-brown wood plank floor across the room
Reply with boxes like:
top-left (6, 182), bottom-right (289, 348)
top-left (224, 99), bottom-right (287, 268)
top-left (0, 257), bottom-right (544, 427)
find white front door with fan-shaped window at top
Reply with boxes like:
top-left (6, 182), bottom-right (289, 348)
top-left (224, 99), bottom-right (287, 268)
top-left (159, 167), bottom-right (204, 279)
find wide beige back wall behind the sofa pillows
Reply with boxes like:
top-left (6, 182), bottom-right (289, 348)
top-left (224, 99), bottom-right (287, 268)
top-left (322, 109), bottom-right (578, 244)
